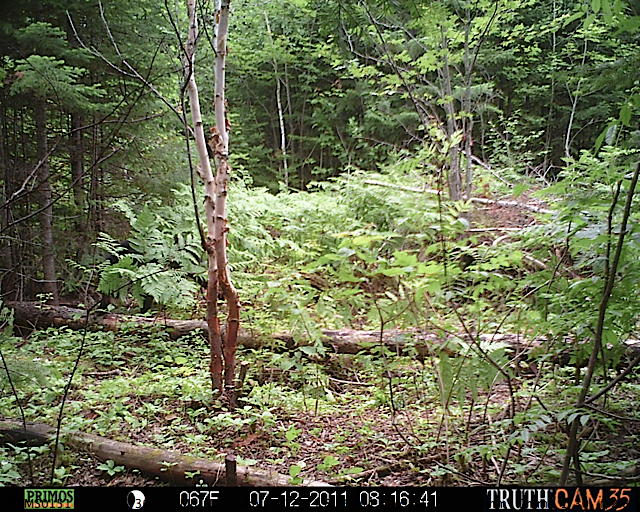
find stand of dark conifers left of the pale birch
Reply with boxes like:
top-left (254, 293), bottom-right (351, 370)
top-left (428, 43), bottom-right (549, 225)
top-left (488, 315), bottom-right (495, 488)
top-left (0, 0), bottom-right (187, 304)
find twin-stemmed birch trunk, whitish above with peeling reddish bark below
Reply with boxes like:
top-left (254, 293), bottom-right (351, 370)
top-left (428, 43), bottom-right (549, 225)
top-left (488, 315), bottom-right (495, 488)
top-left (183, 0), bottom-right (240, 405)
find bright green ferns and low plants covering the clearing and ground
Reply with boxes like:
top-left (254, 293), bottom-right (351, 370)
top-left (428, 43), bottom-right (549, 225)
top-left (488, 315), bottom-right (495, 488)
top-left (0, 152), bottom-right (640, 485)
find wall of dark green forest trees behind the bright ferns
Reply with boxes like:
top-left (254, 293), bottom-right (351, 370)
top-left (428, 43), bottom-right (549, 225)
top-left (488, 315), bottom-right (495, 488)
top-left (0, 0), bottom-right (638, 301)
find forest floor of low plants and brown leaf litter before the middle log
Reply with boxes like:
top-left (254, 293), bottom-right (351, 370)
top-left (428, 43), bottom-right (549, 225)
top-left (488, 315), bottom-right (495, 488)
top-left (5, 199), bottom-right (640, 486)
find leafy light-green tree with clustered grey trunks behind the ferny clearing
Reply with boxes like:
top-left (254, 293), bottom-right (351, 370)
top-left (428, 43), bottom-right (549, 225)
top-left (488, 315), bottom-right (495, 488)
top-left (330, 0), bottom-right (504, 200)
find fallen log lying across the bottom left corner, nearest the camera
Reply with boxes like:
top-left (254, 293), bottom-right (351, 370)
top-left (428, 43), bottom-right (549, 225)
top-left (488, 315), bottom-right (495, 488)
top-left (0, 420), bottom-right (329, 487)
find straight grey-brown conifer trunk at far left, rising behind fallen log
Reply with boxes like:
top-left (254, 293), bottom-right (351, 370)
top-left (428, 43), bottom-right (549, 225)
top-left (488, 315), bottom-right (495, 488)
top-left (35, 99), bottom-right (59, 304)
